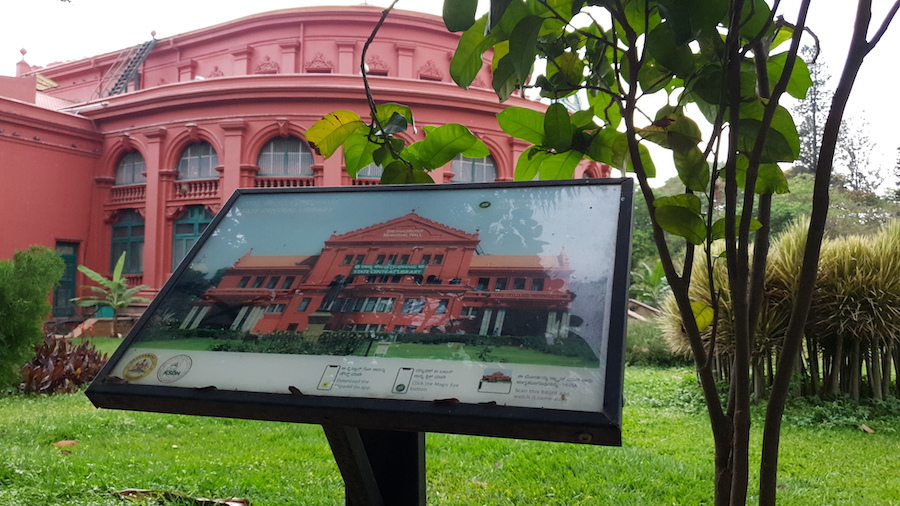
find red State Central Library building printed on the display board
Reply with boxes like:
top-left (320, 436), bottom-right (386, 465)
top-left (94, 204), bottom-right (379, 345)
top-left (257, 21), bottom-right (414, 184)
top-left (181, 213), bottom-right (574, 343)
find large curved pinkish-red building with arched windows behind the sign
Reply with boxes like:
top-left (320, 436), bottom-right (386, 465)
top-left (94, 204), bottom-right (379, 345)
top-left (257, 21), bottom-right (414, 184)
top-left (0, 6), bottom-right (608, 317)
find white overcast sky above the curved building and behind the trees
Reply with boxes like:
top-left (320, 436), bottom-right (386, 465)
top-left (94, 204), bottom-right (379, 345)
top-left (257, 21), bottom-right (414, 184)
top-left (0, 0), bottom-right (900, 186)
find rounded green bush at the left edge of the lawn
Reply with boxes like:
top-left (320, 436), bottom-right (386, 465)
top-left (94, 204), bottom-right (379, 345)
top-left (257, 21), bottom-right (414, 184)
top-left (0, 246), bottom-right (65, 388)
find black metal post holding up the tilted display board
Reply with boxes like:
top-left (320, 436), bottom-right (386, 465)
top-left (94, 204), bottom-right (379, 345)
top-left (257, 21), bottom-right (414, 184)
top-left (322, 425), bottom-right (425, 506)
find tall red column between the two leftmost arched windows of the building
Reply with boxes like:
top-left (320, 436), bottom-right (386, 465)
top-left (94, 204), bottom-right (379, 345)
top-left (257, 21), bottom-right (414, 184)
top-left (143, 128), bottom-right (166, 290)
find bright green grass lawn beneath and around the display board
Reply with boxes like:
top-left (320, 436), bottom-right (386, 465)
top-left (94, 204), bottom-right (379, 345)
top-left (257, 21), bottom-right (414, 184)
top-left (0, 367), bottom-right (900, 506)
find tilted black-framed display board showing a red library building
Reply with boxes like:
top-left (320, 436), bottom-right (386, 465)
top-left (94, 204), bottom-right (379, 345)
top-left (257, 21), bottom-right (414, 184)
top-left (87, 179), bottom-right (632, 445)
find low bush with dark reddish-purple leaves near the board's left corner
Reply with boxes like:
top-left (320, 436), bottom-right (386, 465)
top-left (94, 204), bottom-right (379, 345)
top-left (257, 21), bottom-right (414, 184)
top-left (20, 334), bottom-right (107, 394)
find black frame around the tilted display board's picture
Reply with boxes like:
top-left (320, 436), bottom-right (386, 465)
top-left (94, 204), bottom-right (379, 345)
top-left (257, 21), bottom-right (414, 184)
top-left (87, 178), bottom-right (633, 446)
